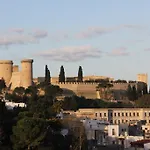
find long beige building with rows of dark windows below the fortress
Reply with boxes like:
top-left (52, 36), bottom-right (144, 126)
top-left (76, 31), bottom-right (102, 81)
top-left (75, 108), bottom-right (150, 124)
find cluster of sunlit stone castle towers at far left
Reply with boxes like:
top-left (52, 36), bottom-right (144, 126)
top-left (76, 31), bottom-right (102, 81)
top-left (0, 59), bottom-right (33, 89)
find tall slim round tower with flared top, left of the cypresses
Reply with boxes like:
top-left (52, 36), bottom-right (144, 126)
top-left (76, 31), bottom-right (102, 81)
top-left (21, 59), bottom-right (33, 88)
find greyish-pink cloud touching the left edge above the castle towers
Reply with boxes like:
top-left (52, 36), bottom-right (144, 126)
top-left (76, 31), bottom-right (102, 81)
top-left (0, 35), bottom-right (38, 47)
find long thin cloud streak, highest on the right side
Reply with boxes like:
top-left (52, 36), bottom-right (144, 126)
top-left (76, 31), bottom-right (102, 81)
top-left (77, 24), bottom-right (144, 38)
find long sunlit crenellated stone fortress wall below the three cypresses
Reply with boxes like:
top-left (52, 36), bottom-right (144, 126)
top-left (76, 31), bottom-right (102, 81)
top-left (35, 76), bottom-right (145, 99)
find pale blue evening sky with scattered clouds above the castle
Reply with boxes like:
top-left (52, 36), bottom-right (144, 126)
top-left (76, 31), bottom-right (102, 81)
top-left (0, 0), bottom-right (150, 80)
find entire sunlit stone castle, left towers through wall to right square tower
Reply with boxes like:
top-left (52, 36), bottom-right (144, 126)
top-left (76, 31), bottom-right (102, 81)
top-left (0, 59), bottom-right (148, 99)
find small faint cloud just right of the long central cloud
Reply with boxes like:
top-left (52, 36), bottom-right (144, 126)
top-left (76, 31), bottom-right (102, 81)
top-left (107, 47), bottom-right (129, 56)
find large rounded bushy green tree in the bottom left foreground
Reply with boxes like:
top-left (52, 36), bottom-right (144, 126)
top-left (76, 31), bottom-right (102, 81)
top-left (11, 117), bottom-right (48, 150)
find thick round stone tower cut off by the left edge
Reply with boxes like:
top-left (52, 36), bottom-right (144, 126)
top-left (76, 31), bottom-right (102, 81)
top-left (0, 60), bottom-right (13, 86)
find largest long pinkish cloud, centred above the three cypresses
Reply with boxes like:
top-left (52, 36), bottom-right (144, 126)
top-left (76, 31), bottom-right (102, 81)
top-left (36, 45), bottom-right (102, 62)
